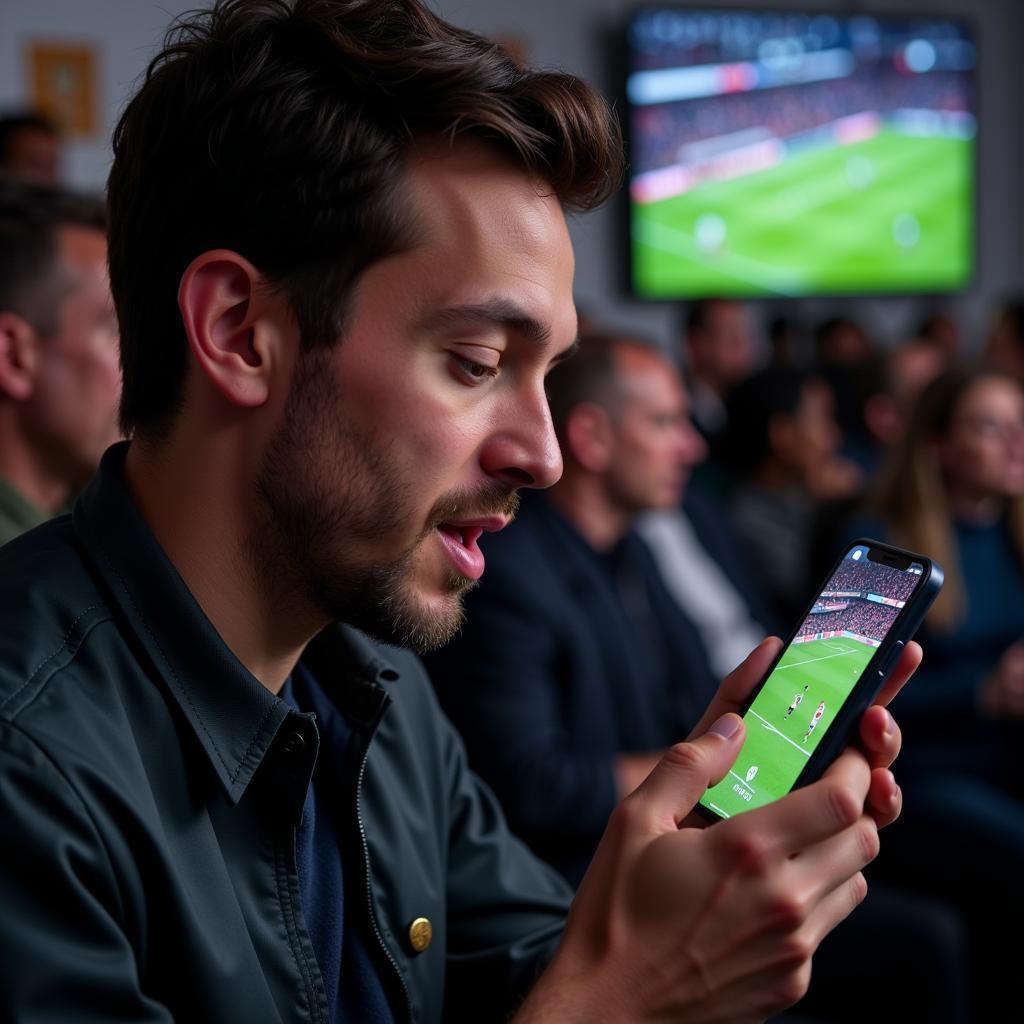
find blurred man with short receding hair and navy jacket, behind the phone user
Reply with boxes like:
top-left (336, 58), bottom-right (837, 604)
top-left (427, 337), bottom-right (720, 884)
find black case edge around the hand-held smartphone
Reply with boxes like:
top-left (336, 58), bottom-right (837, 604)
top-left (696, 538), bottom-right (944, 821)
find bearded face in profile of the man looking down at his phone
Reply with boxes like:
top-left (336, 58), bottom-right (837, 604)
top-left (250, 145), bottom-right (577, 650)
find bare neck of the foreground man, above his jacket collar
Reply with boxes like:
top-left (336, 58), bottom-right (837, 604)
top-left (125, 439), bottom-right (326, 693)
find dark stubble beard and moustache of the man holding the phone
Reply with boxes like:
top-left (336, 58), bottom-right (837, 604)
top-left (247, 352), bottom-right (517, 653)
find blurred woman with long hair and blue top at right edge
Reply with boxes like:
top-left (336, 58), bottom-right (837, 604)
top-left (874, 370), bottom-right (1024, 741)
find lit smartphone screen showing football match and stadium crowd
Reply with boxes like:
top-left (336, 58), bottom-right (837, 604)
top-left (700, 545), bottom-right (925, 818)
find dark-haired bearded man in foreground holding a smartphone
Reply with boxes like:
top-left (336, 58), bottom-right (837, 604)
top-left (0, 0), bottom-right (919, 1022)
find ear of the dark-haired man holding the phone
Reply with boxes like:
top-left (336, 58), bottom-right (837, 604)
top-left (178, 249), bottom-right (274, 408)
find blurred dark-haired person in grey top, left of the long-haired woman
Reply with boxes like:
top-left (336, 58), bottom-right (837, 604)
top-left (722, 367), bottom-right (862, 621)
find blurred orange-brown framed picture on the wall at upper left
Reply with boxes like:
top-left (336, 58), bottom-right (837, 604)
top-left (28, 42), bottom-right (99, 138)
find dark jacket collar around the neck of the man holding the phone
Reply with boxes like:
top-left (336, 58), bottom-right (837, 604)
top-left (73, 442), bottom-right (398, 804)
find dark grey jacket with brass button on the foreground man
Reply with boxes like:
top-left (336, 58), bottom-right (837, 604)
top-left (0, 445), bottom-right (570, 1024)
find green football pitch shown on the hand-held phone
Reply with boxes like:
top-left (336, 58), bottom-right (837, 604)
top-left (700, 637), bottom-right (877, 817)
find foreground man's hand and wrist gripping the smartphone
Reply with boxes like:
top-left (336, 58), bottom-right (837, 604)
top-left (520, 639), bottom-right (921, 1024)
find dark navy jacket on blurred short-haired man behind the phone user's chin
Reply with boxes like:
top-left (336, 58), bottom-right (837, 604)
top-left (426, 494), bottom-right (716, 884)
